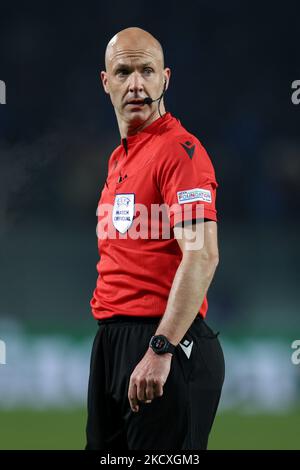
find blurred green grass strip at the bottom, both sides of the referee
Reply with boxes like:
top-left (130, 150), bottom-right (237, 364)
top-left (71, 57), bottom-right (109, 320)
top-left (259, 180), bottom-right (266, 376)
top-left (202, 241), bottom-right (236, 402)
top-left (0, 409), bottom-right (300, 450)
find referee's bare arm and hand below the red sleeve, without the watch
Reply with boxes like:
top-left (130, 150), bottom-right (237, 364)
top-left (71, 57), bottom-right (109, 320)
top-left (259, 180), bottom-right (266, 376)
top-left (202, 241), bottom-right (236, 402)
top-left (128, 221), bottom-right (219, 411)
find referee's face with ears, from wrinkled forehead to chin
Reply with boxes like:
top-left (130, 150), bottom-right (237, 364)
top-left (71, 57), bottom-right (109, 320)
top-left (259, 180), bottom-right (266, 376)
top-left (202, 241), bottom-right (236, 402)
top-left (101, 45), bottom-right (170, 125)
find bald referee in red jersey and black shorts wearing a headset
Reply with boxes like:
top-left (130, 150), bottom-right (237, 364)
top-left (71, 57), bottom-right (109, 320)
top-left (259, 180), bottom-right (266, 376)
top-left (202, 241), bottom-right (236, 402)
top-left (86, 27), bottom-right (224, 451)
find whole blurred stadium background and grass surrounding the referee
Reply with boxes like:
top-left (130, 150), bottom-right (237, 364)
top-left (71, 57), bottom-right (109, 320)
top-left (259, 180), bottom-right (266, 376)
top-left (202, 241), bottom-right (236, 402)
top-left (0, 0), bottom-right (300, 449)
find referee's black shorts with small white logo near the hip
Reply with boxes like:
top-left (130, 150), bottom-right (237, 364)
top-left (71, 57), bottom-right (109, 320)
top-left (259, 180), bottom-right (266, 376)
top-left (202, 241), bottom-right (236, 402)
top-left (86, 316), bottom-right (224, 451)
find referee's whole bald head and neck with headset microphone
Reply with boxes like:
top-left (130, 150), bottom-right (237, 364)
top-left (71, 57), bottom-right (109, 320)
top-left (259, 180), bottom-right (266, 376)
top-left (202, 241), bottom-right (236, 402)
top-left (101, 28), bottom-right (171, 132)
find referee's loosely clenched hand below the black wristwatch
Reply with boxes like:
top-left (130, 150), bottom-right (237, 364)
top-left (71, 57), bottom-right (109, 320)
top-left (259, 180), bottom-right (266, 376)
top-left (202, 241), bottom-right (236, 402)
top-left (128, 348), bottom-right (172, 412)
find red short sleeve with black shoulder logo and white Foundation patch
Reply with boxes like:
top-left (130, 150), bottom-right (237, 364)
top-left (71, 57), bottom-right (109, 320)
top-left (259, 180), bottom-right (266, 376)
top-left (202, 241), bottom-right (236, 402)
top-left (156, 136), bottom-right (218, 228)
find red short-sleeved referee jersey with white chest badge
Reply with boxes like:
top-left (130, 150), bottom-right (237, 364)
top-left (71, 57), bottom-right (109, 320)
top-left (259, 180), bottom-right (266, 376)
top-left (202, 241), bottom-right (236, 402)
top-left (91, 113), bottom-right (218, 319)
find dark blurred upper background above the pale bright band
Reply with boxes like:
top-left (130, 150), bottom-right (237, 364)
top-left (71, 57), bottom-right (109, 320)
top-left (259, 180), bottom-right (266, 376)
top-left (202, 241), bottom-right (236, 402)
top-left (0, 0), bottom-right (300, 334)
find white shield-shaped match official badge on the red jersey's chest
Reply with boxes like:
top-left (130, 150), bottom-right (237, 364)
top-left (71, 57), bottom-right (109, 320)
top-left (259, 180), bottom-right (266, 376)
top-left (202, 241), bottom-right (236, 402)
top-left (112, 193), bottom-right (134, 233)
